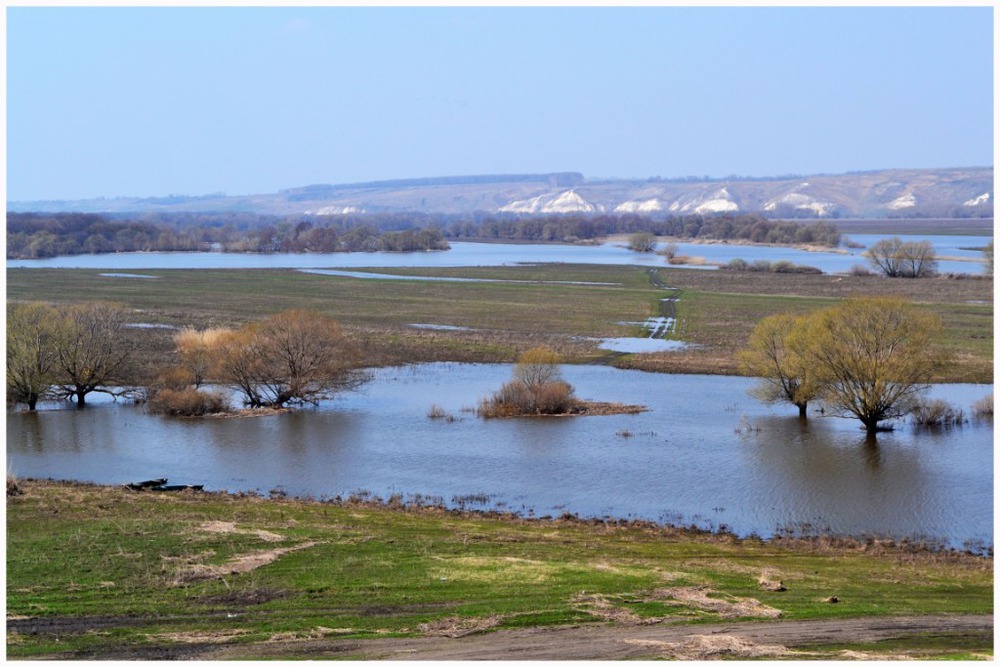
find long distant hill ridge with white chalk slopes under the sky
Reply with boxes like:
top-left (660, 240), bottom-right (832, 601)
top-left (7, 167), bottom-right (994, 219)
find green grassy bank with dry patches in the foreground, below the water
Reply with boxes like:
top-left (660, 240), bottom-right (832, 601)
top-left (7, 480), bottom-right (993, 658)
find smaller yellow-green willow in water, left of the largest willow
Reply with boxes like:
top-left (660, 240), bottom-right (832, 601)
top-left (740, 314), bottom-right (820, 417)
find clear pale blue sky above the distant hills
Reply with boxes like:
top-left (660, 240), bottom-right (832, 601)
top-left (6, 6), bottom-right (994, 200)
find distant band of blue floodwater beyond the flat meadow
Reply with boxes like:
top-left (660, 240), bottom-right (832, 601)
top-left (7, 234), bottom-right (988, 273)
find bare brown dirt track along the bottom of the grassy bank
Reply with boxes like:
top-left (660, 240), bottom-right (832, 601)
top-left (195, 615), bottom-right (993, 660)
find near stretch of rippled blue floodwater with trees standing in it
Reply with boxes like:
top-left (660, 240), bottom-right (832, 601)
top-left (7, 363), bottom-right (993, 547)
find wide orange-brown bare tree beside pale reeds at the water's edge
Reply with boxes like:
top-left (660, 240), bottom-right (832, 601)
top-left (215, 310), bottom-right (366, 408)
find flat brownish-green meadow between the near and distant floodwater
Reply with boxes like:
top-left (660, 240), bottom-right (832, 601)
top-left (7, 264), bottom-right (993, 382)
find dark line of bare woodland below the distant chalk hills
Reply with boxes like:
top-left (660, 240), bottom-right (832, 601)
top-left (7, 212), bottom-right (840, 259)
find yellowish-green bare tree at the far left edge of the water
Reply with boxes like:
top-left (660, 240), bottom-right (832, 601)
top-left (7, 302), bottom-right (60, 410)
